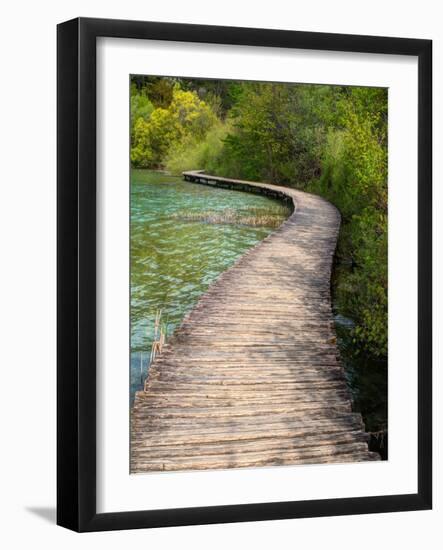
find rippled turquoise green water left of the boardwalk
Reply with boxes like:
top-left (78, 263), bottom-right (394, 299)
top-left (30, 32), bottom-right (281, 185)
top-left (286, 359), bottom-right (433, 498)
top-left (131, 170), bottom-right (290, 400)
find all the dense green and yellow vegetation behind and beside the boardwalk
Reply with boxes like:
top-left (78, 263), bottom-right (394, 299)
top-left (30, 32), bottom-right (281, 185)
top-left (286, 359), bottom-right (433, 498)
top-left (131, 76), bottom-right (387, 357)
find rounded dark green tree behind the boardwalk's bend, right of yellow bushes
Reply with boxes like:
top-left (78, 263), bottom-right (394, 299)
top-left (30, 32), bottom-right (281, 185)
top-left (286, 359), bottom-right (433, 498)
top-left (219, 83), bottom-right (324, 187)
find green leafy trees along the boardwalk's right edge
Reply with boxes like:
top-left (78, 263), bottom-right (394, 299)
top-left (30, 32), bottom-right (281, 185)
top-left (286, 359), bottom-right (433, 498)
top-left (315, 88), bottom-right (388, 356)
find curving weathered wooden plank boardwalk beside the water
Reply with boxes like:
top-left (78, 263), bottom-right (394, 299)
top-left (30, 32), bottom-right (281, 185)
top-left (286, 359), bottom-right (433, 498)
top-left (131, 172), bottom-right (380, 473)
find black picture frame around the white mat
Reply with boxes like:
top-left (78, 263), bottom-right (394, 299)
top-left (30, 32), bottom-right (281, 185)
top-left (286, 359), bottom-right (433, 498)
top-left (57, 18), bottom-right (432, 531)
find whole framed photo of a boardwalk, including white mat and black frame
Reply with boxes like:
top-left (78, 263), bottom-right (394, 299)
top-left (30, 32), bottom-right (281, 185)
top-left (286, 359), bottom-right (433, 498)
top-left (57, 18), bottom-right (432, 531)
